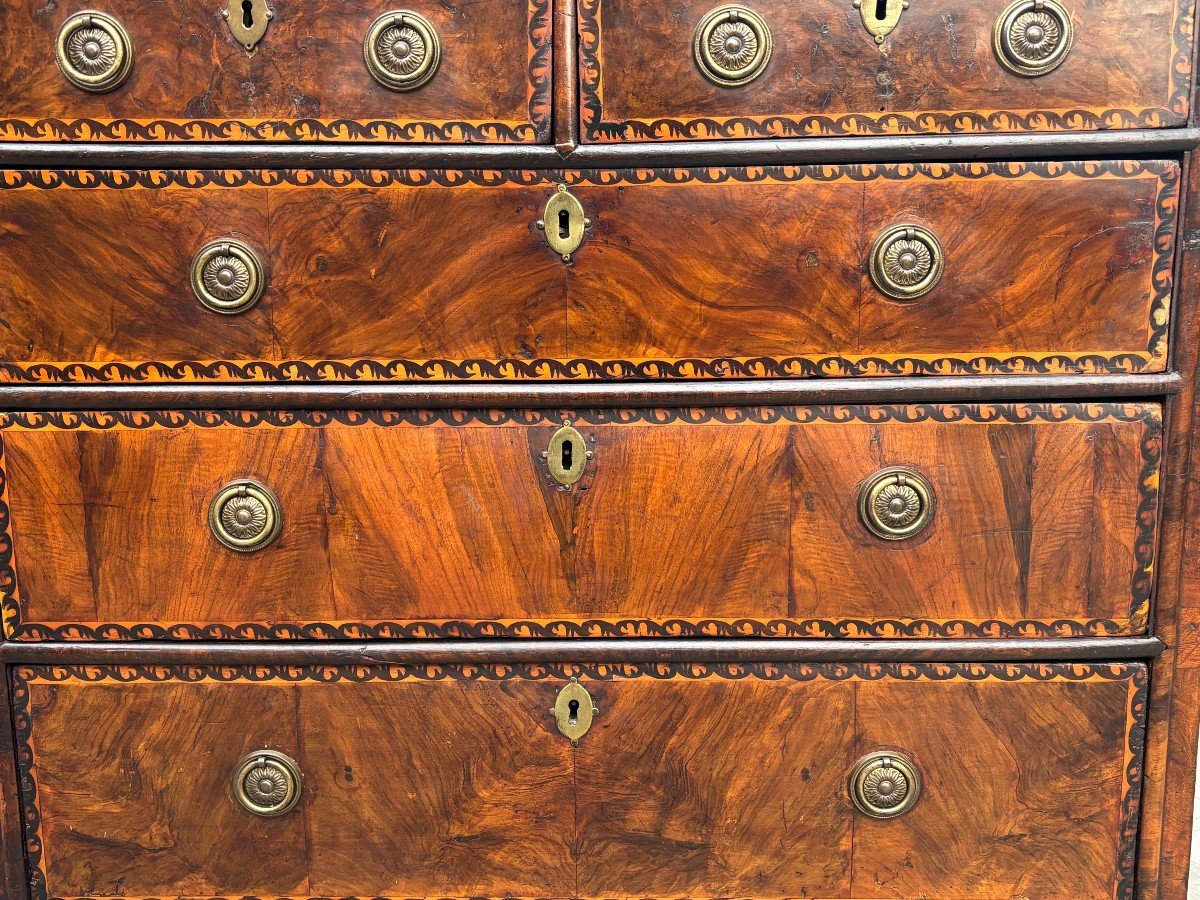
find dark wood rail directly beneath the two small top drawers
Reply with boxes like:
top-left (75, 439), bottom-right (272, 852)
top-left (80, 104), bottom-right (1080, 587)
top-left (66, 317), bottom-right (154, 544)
top-left (0, 127), bottom-right (1200, 169)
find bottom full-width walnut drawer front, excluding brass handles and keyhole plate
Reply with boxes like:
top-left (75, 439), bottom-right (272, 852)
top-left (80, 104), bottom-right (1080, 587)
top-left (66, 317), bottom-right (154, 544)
top-left (14, 664), bottom-right (1147, 898)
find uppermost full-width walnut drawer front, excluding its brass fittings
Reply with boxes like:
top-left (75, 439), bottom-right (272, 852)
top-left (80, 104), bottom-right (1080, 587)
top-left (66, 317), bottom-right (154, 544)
top-left (0, 161), bottom-right (1178, 382)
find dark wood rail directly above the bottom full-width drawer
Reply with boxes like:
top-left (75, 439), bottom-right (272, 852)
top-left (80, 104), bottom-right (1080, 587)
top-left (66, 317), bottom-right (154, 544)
top-left (0, 637), bottom-right (1165, 666)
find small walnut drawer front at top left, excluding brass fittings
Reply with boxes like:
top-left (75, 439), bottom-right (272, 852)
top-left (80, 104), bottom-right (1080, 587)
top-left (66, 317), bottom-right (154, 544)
top-left (0, 0), bottom-right (551, 143)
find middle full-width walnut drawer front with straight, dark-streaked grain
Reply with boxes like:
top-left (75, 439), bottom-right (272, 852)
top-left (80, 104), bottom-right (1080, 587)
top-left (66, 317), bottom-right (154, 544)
top-left (0, 403), bottom-right (1162, 640)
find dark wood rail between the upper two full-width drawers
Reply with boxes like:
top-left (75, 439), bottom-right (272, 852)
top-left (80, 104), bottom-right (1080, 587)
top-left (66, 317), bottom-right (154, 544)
top-left (0, 372), bottom-right (1183, 412)
